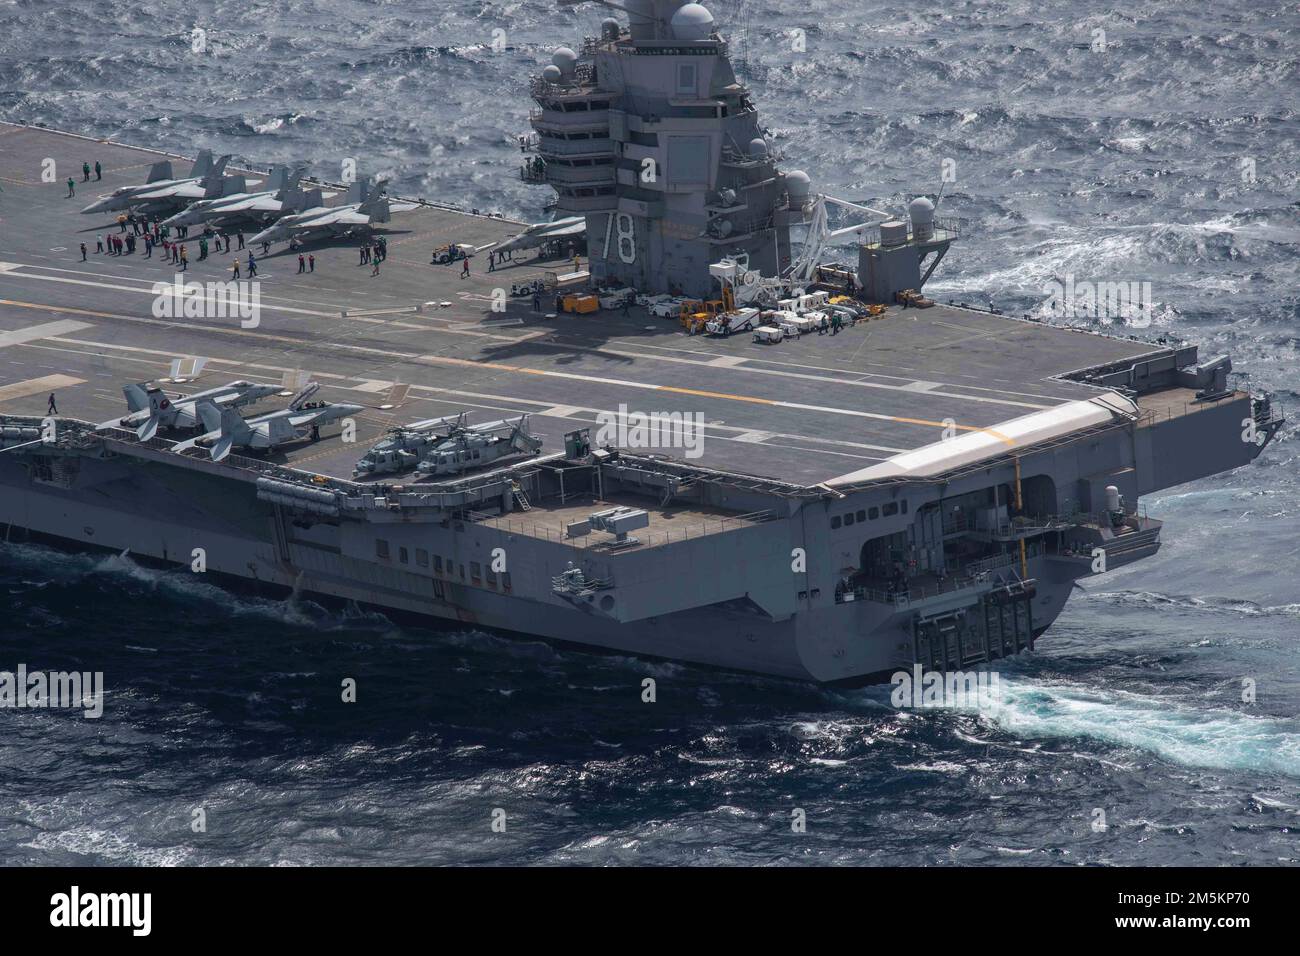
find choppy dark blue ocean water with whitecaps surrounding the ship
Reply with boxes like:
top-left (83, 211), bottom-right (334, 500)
top-left (0, 0), bottom-right (1300, 865)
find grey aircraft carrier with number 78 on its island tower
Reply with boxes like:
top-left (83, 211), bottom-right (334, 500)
top-left (0, 0), bottom-right (1281, 682)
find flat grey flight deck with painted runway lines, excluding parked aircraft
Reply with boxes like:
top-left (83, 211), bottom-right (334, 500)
top-left (0, 125), bottom-right (1170, 485)
